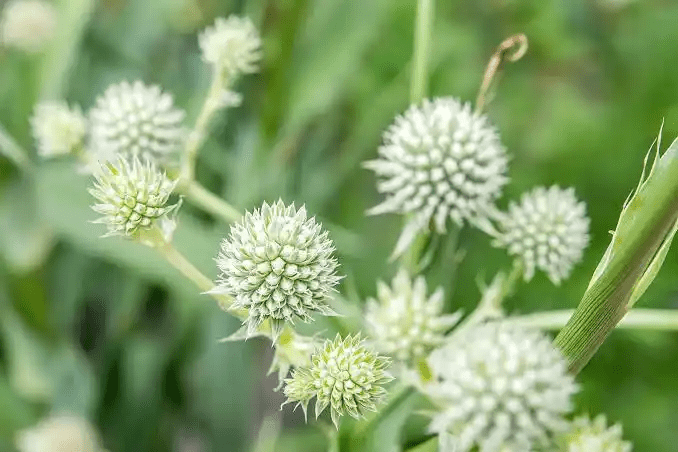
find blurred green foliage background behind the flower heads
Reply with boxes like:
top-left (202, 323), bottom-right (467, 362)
top-left (0, 0), bottom-right (678, 452)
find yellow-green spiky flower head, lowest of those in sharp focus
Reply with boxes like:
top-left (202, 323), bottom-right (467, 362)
top-left (284, 334), bottom-right (393, 428)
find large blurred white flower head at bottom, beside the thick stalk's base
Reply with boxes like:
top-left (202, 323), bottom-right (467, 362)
top-left (426, 323), bottom-right (577, 452)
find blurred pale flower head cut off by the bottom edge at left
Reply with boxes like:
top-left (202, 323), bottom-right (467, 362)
top-left (16, 414), bottom-right (103, 452)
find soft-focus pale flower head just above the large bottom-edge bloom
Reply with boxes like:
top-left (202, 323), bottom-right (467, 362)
top-left (365, 269), bottom-right (460, 364)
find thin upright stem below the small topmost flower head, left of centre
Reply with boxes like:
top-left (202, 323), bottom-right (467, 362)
top-left (181, 68), bottom-right (225, 181)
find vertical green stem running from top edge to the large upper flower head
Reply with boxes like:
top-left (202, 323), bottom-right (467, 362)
top-left (410, 0), bottom-right (435, 104)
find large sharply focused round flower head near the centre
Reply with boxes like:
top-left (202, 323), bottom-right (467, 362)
top-left (215, 201), bottom-right (340, 339)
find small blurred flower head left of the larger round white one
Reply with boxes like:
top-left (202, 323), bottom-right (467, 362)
top-left (31, 102), bottom-right (87, 157)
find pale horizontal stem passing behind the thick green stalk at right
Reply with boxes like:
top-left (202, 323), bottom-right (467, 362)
top-left (506, 309), bottom-right (678, 331)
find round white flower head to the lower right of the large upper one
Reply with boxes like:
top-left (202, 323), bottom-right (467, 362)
top-left (494, 186), bottom-right (589, 284)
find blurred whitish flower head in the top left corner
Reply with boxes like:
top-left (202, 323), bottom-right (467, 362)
top-left (0, 0), bottom-right (57, 53)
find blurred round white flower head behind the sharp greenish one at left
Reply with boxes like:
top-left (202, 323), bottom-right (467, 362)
top-left (89, 81), bottom-right (185, 164)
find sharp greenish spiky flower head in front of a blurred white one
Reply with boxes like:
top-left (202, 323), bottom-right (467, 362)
top-left (89, 157), bottom-right (178, 238)
